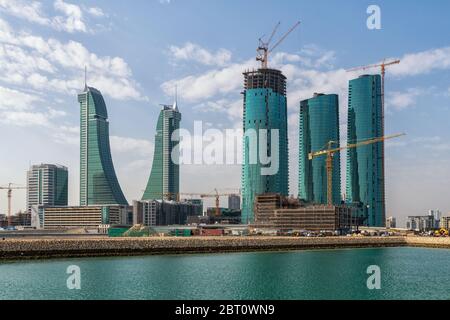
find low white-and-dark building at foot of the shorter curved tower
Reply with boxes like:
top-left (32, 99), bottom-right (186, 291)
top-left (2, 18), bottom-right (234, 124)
top-left (133, 200), bottom-right (200, 226)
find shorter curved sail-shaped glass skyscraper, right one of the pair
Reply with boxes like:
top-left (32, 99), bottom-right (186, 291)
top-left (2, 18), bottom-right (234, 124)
top-left (142, 102), bottom-right (181, 200)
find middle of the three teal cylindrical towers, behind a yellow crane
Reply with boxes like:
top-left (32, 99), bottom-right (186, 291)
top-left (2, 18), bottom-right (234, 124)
top-left (298, 94), bottom-right (341, 205)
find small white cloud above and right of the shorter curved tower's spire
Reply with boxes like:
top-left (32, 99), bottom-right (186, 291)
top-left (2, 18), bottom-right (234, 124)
top-left (169, 42), bottom-right (231, 66)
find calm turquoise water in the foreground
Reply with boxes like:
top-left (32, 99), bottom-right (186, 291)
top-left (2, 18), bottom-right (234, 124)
top-left (0, 248), bottom-right (450, 299)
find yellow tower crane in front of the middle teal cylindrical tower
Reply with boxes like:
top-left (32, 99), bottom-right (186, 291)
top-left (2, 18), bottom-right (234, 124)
top-left (308, 133), bottom-right (405, 206)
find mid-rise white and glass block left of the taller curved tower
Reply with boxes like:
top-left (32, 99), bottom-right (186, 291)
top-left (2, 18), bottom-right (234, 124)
top-left (27, 164), bottom-right (68, 213)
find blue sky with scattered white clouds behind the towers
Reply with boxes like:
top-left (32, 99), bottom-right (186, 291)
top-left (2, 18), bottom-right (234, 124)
top-left (0, 0), bottom-right (450, 225)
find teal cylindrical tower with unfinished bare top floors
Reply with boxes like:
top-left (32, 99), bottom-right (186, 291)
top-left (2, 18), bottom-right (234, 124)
top-left (241, 69), bottom-right (289, 224)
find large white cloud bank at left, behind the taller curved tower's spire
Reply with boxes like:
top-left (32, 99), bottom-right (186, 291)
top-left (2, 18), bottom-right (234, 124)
top-left (0, 17), bottom-right (147, 100)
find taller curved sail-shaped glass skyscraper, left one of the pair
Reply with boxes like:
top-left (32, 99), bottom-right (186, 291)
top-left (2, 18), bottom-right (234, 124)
top-left (78, 86), bottom-right (128, 206)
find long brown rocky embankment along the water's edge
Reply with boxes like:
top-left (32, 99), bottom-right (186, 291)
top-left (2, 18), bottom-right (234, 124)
top-left (0, 236), bottom-right (450, 262)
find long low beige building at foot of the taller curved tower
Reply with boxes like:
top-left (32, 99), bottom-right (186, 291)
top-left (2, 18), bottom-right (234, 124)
top-left (31, 205), bottom-right (132, 229)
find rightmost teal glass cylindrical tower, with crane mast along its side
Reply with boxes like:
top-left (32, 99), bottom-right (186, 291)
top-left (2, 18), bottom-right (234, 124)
top-left (346, 75), bottom-right (386, 227)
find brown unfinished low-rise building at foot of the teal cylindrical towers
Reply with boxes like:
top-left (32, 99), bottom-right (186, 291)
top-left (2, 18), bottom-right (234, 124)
top-left (252, 194), bottom-right (354, 232)
